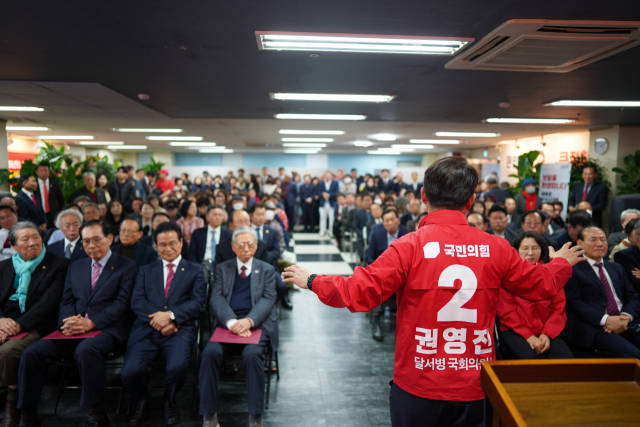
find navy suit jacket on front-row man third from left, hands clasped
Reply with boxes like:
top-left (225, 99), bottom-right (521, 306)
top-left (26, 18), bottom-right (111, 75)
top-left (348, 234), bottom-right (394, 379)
top-left (127, 259), bottom-right (207, 348)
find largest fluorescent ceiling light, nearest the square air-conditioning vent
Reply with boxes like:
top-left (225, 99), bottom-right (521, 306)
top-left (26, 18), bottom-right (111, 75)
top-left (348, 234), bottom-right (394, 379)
top-left (256, 31), bottom-right (474, 55)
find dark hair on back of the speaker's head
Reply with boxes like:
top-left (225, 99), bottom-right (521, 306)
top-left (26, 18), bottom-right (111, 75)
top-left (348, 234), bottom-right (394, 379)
top-left (423, 157), bottom-right (478, 210)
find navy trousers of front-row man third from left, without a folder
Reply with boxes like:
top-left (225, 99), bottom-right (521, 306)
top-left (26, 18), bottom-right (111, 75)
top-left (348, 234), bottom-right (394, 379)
top-left (122, 331), bottom-right (191, 407)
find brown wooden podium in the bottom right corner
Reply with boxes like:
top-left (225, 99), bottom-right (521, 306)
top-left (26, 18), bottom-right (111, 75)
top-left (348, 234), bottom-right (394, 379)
top-left (480, 359), bottom-right (640, 427)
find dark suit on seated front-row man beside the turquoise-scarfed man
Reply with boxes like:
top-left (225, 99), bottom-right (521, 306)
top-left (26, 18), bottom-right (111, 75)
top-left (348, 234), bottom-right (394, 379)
top-left (18, 253), bottom-right (136, 409)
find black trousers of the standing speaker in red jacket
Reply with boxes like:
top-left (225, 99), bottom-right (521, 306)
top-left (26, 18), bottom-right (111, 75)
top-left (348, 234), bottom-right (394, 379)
top-left (389, 383), bottom-right (484, 427)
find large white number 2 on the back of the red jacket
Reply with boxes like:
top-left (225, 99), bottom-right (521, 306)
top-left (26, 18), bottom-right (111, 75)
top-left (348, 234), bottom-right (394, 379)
top-left (438, 264), bottom-right (478, 323)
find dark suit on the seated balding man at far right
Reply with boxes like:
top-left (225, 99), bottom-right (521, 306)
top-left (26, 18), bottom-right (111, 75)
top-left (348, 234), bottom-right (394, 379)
top-left (564, 261), bottom-right (640, 358)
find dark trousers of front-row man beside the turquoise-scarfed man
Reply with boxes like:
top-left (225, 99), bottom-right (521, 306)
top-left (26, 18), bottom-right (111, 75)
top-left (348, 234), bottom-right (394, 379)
top-left (18, 332), bottom-right (117, 409)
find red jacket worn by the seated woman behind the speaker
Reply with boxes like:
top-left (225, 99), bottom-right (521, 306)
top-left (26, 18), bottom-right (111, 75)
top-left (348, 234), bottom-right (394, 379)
top-left (498, 263), bottom-right (567, 339)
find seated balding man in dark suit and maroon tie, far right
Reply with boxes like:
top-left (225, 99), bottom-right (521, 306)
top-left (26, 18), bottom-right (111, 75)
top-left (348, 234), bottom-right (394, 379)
top-left (564, 226), bottom-right (640, 359)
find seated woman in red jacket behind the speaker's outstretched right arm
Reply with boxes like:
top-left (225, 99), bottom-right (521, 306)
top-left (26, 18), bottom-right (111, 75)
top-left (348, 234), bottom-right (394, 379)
top-left (497, 231), bottom-right (573, 359)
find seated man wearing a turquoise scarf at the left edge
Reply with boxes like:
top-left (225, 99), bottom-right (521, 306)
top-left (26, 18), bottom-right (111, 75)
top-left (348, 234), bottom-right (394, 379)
top-left (0, 222), bottom-right (69, 427)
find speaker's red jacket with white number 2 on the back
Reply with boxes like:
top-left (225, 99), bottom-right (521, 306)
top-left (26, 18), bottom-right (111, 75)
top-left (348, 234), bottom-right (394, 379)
top-left (312, 210), bottom-right (572, 401)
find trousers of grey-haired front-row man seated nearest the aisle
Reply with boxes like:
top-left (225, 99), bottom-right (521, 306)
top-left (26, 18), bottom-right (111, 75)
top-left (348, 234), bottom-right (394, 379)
top-left (198, 330), bottom-right (269, 415)
